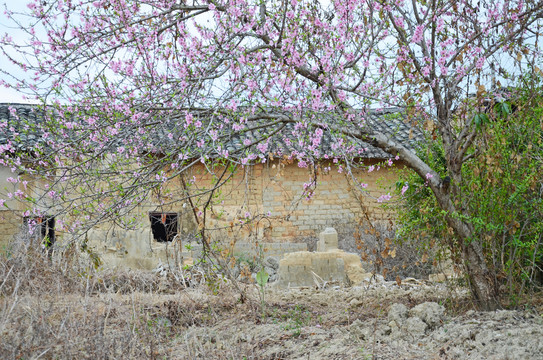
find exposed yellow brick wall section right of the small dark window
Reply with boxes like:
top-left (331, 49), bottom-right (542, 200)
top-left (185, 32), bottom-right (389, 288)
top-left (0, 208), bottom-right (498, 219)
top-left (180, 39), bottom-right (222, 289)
top-left (173, 161), bottom-right (404, 241)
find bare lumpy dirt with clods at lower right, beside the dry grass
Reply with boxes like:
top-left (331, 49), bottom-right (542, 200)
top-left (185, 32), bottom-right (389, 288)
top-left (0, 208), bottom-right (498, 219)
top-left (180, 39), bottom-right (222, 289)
top-left (173, 286), bottom-right (543, 359)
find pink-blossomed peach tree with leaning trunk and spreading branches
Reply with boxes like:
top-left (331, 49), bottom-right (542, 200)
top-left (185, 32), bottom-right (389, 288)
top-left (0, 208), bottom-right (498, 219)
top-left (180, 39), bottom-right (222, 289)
top-left (0, 0), bottom-right (543, 309)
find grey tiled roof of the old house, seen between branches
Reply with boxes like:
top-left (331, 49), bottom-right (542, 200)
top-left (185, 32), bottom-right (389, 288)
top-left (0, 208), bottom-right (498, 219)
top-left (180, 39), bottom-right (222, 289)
top-left (0, 104), bottom-right (423, 159)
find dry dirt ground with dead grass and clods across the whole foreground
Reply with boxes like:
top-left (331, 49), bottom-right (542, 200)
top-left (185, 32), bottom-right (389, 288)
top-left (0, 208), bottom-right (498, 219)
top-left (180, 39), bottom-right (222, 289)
top-left (0, 275), bottom-right (543, 359)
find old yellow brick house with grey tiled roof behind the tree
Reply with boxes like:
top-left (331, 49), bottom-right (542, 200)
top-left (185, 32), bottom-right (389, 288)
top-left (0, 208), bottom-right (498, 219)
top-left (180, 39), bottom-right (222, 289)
top-left (0, 104), bottom-right (420, 268)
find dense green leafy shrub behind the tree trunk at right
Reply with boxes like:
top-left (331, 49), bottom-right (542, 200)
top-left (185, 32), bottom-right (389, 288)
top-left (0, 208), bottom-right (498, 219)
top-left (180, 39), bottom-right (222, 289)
top-left (397, 80), bottom-right (543, 300)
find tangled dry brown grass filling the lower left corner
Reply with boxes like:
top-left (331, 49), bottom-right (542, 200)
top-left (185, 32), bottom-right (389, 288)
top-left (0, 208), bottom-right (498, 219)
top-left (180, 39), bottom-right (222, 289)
top-left (0, 236), bottom-right (220, 359)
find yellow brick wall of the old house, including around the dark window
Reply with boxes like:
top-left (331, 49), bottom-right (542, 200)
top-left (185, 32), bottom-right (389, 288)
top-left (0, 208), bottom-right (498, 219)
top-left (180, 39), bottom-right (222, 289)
top-left (0, 160), bottom-right (404, 248)
